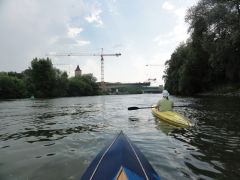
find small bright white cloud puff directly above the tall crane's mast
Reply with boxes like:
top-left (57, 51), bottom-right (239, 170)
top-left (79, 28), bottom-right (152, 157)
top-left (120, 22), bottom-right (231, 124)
top-left (85, 7), bottom-right (103, 26)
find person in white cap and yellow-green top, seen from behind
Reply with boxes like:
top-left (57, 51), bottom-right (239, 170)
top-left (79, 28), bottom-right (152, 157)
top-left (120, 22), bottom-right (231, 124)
top-left (156, 90), bottom-right (173, 112)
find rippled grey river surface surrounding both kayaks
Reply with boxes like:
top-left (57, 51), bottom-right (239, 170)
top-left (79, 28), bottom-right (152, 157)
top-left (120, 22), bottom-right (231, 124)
top-left (0, 94), bottom-right (240, 180)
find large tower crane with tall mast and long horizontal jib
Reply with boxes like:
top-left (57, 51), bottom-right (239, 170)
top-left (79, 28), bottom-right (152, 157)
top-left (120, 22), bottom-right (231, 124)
top-left (47, 48), bottom-right (121, 87)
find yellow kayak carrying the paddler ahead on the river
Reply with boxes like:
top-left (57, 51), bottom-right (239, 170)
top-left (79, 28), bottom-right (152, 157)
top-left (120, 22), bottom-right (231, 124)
top-left (152, 108), bottom-right (193, 128)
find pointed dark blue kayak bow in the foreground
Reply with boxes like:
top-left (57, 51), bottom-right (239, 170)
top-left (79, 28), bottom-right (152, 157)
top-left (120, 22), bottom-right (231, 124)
top-left (81, 131), bottom-right (160, 180)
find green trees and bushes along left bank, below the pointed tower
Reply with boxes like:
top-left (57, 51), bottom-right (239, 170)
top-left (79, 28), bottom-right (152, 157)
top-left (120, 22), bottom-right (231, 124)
top-left (0, 58), bottom-right (100, 99)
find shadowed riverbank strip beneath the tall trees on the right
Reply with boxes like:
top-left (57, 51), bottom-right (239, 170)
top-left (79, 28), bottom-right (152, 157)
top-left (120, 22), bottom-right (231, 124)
top-left (197, 84), bottom-right (240, 97)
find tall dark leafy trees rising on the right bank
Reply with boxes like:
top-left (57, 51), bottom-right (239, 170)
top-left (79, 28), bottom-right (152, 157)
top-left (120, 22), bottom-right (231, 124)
top-left (163, 0), bottom-right (240, 95)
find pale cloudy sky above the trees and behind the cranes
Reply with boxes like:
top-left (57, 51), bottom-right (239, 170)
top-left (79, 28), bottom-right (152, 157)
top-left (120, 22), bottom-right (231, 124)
top-left (0, 0), bottom-right (197, 85)
